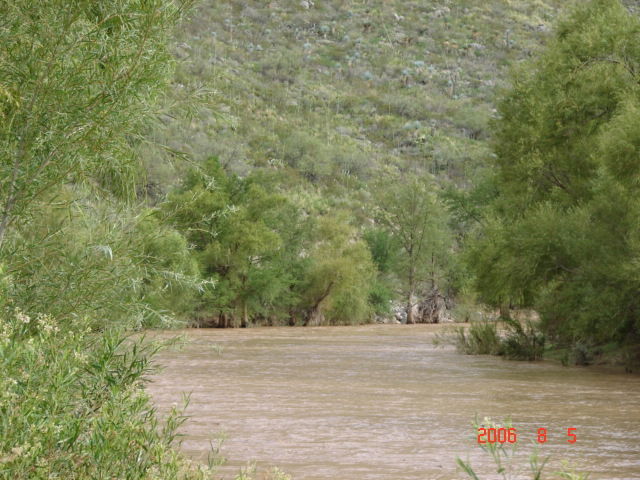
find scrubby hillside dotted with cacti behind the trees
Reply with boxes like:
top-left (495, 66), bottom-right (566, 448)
top-left (151, 0), bottom-right (566, 197)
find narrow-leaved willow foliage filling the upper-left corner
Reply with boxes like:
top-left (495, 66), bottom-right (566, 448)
top-left (0, 0), bottom-right (190, 247)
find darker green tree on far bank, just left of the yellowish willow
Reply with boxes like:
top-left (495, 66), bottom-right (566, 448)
top-left (163, 157), bottom-right (297, 326)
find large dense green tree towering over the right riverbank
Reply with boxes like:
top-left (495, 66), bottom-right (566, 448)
top-left (470, 0), bottom-right (640, 343)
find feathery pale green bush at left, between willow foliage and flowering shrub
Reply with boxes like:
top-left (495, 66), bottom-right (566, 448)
top-left (0, 189), bottom-right (205, 329)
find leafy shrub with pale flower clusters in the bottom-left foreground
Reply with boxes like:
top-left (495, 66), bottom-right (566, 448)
top-left (0, 309), bottom-right (214, 480)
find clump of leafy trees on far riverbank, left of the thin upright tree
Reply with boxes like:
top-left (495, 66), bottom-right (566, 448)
top-left (158, 157), bottom-right (375, 327)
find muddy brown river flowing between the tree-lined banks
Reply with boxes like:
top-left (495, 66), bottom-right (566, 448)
top-left (148, 325), bottom-right (640, 480)
